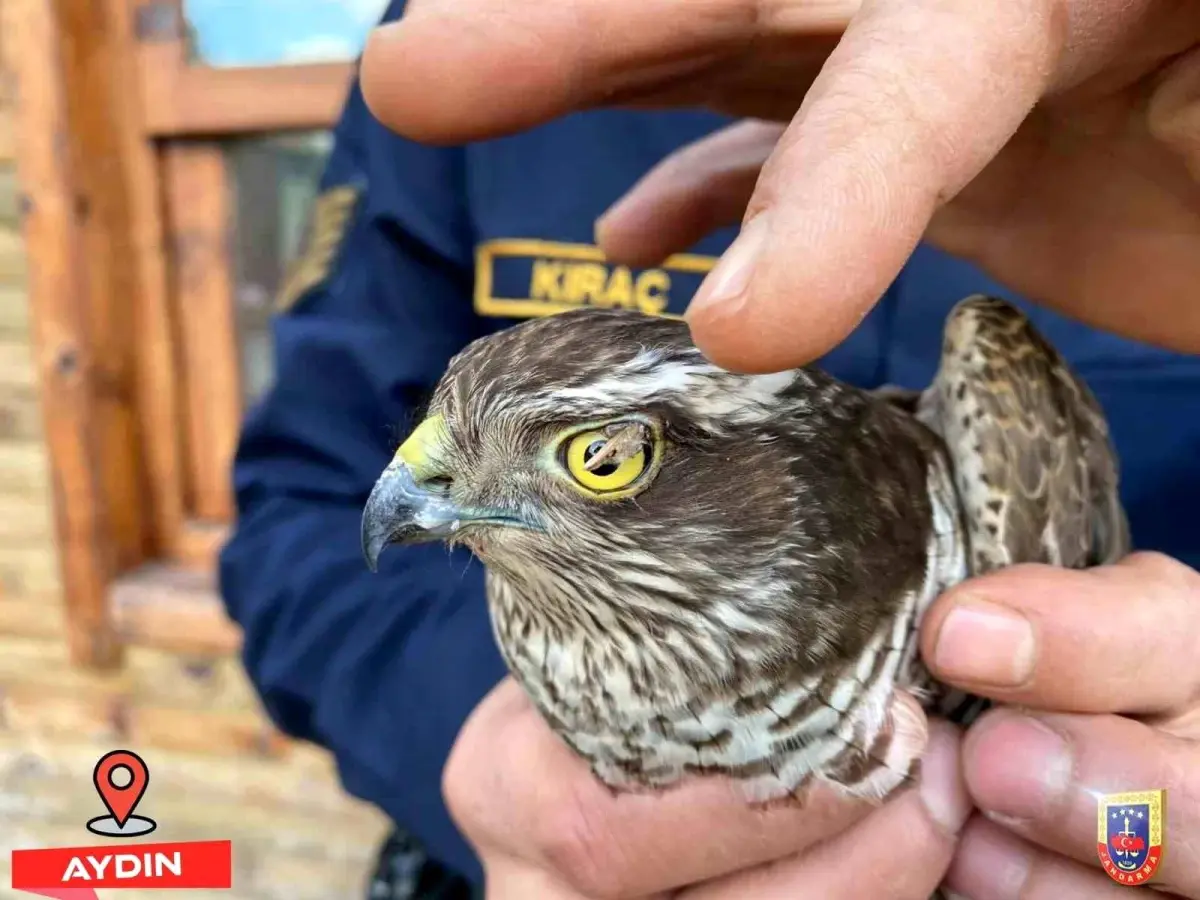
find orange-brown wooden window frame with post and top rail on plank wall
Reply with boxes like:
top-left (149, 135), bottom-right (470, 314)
top-left (0, 0), bottom-right (354, 667)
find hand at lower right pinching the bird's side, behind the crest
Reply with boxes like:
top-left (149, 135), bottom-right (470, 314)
top-left (922, 553), bottom-right (1200, 900)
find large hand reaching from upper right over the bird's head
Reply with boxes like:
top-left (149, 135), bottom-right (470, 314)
top-left (361, 0), bottom-right (1200, 371)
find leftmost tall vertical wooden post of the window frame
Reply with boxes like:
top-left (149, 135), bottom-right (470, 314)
top-left (0, 0), bottom-right (128, 666)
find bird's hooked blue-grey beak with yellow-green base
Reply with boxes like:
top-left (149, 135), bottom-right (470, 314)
top-left (361, 415), bottom-right (538, 572)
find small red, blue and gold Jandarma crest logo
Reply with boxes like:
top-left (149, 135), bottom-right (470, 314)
top-left (1096, 791), bottom-right (1166, 886)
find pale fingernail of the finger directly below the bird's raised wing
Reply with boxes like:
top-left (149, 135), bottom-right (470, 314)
top-left (934, 599), bottom-right (1037, 688)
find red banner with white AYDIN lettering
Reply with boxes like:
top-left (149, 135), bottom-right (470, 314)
top-left (12, 841), bottom-right (233, 898)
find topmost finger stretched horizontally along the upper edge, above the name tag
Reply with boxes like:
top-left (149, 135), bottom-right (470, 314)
top-left (360, 0), bottom-right (858, 143)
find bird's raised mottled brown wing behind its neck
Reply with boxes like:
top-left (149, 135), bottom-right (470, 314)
top-left (917, 295), bottom-right (1129, 575)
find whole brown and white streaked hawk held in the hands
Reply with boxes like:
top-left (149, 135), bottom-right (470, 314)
top-left (362, 295), bottom-right (1129, 802)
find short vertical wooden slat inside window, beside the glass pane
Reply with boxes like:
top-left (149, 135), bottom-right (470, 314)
top-left (163, 142), bottom-right (241, 522)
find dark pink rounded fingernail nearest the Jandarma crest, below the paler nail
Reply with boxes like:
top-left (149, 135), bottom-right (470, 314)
top-left (964, 712), bottom-right (1073, 824)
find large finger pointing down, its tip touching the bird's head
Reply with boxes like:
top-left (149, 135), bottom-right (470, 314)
top-left (688, 0), bottom-right (1062, 372)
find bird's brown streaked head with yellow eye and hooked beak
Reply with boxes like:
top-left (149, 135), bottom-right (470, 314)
top-left (362, 310), bottom-right (809, 607)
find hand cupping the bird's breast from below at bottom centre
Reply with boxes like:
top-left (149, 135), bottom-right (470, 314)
top-left (443, 679), bottom-right (970, 900)
